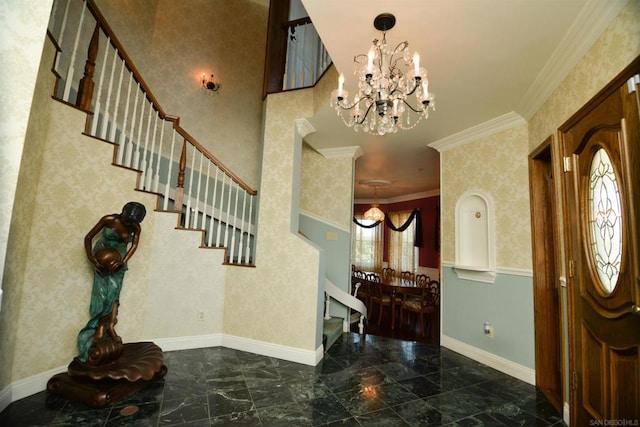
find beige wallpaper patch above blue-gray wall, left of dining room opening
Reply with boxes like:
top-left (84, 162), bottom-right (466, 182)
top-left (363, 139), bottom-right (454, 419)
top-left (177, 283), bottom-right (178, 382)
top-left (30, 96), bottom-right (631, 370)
top-left (300, 144), bottom-right (354, 230)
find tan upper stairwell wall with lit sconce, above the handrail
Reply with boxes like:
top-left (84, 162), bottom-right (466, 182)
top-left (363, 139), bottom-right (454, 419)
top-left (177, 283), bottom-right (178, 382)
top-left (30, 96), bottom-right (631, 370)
top-left (98, 0), bottom-right (269, 188)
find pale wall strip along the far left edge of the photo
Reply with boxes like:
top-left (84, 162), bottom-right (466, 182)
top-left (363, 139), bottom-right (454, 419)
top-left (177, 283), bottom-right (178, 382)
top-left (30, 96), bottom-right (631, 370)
top-left (0, 0), bottom-right (52, 378)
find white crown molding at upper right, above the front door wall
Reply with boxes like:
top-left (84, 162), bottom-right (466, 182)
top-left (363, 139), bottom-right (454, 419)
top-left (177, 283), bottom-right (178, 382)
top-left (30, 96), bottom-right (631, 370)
top-left (516, 0), bottom-right (627, 120)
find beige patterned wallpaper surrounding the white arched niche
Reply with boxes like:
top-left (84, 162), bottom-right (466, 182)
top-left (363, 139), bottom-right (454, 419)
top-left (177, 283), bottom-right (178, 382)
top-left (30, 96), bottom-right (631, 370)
top-left (440, 125), bottom-right (532, 270)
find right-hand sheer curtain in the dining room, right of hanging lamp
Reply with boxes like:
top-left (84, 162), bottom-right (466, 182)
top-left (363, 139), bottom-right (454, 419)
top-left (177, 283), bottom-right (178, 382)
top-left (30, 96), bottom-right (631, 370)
top-left (387, 211), bottom-right (418, 274)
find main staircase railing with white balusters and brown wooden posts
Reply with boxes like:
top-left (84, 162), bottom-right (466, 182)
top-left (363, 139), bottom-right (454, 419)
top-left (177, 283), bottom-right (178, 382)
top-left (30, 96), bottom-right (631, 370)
top-left (48, 0), bottom-right (257, 265)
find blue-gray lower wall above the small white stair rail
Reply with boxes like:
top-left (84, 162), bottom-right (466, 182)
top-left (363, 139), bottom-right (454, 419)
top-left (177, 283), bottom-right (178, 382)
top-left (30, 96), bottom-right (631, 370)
top-left (298, 213), bottom-right (351, 318)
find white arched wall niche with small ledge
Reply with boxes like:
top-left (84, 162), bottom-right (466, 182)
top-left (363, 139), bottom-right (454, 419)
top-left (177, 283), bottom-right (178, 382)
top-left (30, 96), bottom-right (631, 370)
top-left (454, 190), bottom-right (496, 283)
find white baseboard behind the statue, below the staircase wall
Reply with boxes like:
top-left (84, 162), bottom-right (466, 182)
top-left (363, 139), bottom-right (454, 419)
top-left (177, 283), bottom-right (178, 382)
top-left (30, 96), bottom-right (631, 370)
top-left (0, 334), bottom-right (324, 412)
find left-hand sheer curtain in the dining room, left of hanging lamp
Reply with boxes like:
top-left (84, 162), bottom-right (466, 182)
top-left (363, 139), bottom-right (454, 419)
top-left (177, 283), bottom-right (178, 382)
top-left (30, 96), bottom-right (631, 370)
top-left (351, 214), bottom-right (384, 271)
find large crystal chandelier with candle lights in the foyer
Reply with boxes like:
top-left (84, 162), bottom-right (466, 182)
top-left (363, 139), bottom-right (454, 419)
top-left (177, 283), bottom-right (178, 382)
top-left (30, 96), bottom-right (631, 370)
top-left (331, 13), bottom-right (435, 135)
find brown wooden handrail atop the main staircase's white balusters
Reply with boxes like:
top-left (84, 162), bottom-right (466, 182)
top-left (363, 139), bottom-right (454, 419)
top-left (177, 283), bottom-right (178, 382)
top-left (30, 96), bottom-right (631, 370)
top-left (83, 0), bottom-right (258, 196)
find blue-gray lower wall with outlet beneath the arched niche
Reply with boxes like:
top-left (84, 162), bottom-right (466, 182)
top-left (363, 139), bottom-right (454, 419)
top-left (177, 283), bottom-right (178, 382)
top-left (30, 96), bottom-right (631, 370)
top-left (441, 267), bottom-right (535, 369)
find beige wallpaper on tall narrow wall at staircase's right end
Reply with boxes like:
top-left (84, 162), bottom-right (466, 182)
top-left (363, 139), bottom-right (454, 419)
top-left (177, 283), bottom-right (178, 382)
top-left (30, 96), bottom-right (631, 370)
top-left (224, 89), bottom-right (323, 351)
